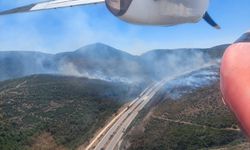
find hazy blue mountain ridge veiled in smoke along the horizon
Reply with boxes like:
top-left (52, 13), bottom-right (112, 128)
top-left (0, 43), bottom-right (228, 82)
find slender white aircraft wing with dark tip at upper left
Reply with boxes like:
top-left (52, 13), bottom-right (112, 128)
top-left (0, 0), bottom-right (105, 15)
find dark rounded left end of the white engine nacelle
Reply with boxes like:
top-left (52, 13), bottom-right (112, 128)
top-left (106, 0), bottom-right (132, 16)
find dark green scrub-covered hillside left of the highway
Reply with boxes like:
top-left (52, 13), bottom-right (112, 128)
top-left (0, 75), bottom-right (137, 150)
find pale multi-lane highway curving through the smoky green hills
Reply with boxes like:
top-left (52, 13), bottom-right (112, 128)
top-left (85, 66), bottom-right (215, 150)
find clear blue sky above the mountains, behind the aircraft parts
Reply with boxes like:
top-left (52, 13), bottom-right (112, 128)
top-left (0, 0), bottom-right (250, 55)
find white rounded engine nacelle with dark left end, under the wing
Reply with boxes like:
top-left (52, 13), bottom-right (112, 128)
top-left (106, 0), bottom-right (209, 26)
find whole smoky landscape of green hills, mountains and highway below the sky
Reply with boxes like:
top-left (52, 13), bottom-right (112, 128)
top-left (0, 43), bottom-right (248, 150)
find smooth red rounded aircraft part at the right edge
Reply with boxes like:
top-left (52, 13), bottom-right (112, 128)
top-left (220, 42), bottom-right (250, 138)
